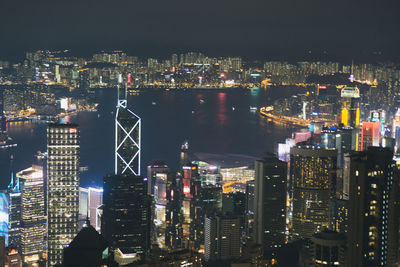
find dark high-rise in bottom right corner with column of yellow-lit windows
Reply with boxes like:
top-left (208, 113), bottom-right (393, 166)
top-left (346, 147), bottom-right (395, 267)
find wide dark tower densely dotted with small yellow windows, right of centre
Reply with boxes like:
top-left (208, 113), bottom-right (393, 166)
top-left (290, 147), bottom-right (337, 239)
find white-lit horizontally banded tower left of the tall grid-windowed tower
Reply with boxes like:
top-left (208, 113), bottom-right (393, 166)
top-left (16, 166), bottom-right (46, 263)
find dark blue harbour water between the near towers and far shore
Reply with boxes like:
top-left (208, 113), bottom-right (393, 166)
top-left (0, 88), bottom-right (298, 188)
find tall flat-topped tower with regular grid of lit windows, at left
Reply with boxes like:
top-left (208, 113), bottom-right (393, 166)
top-left (47, 124), bottom-right (80, 265)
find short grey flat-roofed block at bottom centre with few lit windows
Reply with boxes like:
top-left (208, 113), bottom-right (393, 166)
top-left (204, 215), bottom-right (241, 261)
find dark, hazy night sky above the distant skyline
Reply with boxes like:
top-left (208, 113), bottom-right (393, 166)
top-left (0, 0), bottom-right (400, 61)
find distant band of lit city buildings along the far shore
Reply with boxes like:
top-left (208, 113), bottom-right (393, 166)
top-left (0, 50), bottom-right (400, 90)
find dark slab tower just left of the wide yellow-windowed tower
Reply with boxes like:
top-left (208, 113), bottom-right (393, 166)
top-left (253, 156), bottom-right (287, 251)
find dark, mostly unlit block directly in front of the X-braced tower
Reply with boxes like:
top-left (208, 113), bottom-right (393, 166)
top-left (101, 174), bottom-right (151, 255)
